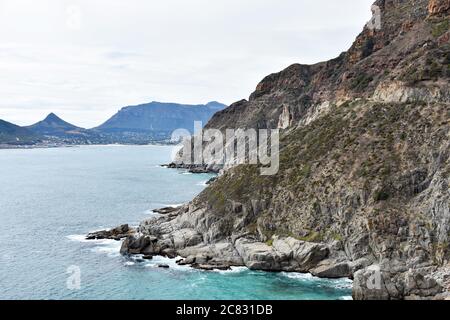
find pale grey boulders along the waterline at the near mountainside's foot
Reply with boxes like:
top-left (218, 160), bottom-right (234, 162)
top-left (86, 205), bottom-right (450, 300)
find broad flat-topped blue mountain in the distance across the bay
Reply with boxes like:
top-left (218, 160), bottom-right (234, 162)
top-left (94, 102), bottom-right (226, 141)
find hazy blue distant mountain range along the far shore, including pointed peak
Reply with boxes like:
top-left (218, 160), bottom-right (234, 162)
top-left (0, 102), bottom-right (227, 146)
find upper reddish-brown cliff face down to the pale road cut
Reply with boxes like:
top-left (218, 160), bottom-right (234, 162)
top-left (208, 0), bottom-right (450, 129)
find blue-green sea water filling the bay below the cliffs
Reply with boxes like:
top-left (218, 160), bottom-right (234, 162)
top-left (0, 146), bottom-right (351, 300)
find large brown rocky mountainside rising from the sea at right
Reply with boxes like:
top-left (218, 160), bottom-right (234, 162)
top-left (126, 0), bottom-right (450, 300)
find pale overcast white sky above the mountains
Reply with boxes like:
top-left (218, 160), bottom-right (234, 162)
top-left (0, 0), bottom-right (374, 128)
